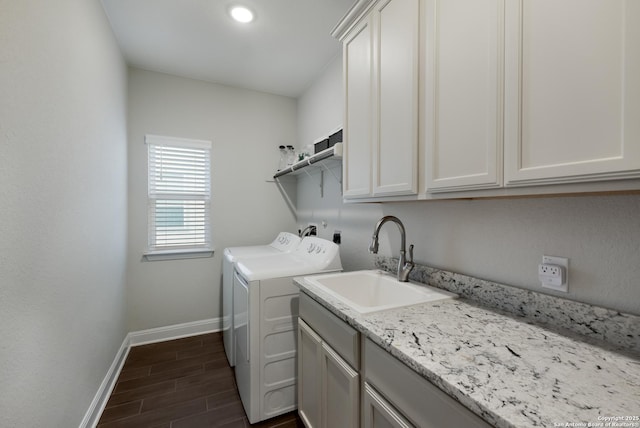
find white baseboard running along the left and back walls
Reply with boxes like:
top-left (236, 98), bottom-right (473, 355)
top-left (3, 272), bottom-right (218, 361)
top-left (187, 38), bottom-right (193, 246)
top-left (79, 318), bottom-right (222, 428)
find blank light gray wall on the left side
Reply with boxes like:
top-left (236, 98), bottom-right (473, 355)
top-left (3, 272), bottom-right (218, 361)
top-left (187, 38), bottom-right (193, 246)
top-left (0, 0), bottom-right (127, 427)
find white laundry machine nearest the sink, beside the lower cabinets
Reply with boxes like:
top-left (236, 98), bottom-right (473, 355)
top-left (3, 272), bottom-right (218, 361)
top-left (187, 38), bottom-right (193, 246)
top-left (233, 237), bottom-right (342, 424)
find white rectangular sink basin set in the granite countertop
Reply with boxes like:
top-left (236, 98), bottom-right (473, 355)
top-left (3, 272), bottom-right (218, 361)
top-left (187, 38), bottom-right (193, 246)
top-left (305, 270), bottom-right (458, 314)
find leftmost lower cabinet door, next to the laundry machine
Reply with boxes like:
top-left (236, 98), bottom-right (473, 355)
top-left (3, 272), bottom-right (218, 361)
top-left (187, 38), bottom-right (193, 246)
top-left (298, 319), bottom-right (322, 428)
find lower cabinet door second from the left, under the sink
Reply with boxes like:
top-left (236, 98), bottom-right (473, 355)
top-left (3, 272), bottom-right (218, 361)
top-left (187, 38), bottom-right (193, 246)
top-left (322, 343), bottom-right (360, 428)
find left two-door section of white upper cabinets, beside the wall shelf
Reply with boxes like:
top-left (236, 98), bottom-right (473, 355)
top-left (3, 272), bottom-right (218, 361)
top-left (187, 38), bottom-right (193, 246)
top-left (341, 0), bottom-right (419, 199)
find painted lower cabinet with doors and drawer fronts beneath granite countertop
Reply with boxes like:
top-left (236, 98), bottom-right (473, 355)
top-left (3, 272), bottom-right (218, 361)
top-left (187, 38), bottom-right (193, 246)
top-left (298, 293), bottom-right (490, 428)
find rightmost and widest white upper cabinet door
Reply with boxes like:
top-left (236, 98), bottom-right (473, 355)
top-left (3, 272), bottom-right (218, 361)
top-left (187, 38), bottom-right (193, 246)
top-left (505, 0), bottom-right (640, 185)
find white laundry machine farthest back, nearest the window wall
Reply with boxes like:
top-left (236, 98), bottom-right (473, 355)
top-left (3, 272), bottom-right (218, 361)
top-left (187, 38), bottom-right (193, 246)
top-left (222, 232), bottom-right (301, 367)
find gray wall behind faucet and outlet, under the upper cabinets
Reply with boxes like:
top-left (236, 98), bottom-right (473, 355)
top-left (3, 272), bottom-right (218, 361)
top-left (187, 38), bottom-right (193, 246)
top-left (297, 53), bottom-right (640, 314)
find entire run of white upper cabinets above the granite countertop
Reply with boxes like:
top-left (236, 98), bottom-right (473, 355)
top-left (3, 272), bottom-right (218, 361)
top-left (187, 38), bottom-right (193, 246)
top-left (334, 0), bottom-right (640, 201)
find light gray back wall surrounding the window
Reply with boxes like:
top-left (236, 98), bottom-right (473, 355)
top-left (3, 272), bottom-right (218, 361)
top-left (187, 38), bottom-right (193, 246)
top-left (127, 69), bottom-right (296, 331)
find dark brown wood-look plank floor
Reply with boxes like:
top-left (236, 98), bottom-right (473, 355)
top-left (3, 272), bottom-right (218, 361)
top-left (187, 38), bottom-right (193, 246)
top-left (98, 333), bottom-right (303, 428)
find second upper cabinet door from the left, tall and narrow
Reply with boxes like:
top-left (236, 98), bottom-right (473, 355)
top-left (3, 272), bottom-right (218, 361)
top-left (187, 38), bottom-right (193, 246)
top-left (373, 0), bottom-right (420, 196)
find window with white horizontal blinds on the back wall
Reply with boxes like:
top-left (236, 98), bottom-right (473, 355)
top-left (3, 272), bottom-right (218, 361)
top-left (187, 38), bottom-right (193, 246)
top-left (145, 135), bottom-right (213, 260)
